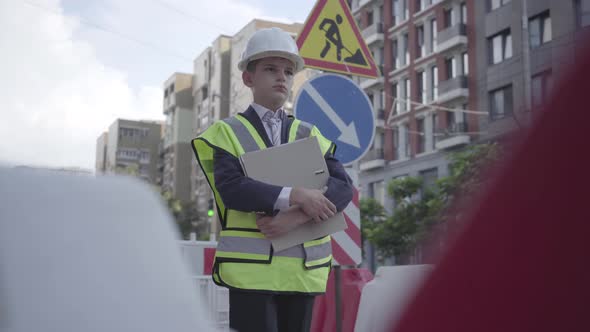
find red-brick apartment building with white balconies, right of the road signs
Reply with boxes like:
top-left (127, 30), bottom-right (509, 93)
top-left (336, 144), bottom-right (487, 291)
top-left (351, 0), bottom-right (478, 208)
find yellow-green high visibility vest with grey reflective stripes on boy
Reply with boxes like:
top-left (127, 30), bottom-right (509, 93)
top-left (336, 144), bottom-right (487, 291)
top-left (192, 115), bottom-right (335, 294)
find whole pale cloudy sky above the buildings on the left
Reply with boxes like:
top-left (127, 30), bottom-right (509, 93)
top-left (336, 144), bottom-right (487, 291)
top-left (0, 0), bottom-right (315, 169)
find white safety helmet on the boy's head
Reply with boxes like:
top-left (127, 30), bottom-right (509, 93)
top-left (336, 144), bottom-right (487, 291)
top-left (238, 28), bottom-right (304, 72)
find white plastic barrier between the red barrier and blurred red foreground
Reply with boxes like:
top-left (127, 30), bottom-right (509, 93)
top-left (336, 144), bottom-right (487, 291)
top-left (354, 265), bottom-right (432, 332)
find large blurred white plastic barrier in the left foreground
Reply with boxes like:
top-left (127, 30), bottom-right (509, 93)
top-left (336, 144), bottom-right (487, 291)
top-left (0, 168), bottom-right (214, 332)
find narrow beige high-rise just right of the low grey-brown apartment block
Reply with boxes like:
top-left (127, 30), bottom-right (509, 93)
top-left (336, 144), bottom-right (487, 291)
top-left (160, 73), bottom-right (194, 203)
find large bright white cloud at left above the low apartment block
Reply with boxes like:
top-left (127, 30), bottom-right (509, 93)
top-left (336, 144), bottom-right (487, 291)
top-left (0, 0), bottom-right (163, 168)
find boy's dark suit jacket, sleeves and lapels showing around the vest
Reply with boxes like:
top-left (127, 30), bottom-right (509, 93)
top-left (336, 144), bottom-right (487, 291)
top-left (213, 107), bottom-right (352, 214)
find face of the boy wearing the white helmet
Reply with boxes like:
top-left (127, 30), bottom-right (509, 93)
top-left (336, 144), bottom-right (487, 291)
top-left (242, 57), bottom-right (295, 111)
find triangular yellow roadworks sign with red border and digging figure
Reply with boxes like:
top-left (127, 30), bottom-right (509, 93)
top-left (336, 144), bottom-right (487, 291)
top-left (297, 0), bottom-right (379, 78)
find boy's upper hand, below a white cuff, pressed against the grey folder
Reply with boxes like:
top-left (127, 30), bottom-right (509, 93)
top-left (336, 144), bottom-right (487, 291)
top-left (289, 188), bottom-right (337, 222)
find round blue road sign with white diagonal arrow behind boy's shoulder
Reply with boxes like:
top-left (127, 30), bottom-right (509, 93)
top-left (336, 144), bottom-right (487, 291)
top-left (294, 74), bottom-right (375, 165)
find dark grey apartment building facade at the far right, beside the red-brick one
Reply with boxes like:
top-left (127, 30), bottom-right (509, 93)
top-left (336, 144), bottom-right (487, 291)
top-left (475, 0), bottom-right (590, 139)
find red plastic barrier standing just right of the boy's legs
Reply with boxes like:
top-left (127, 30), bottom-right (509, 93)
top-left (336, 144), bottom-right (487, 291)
top-left (311, 269), bottom-right (373, 332)
